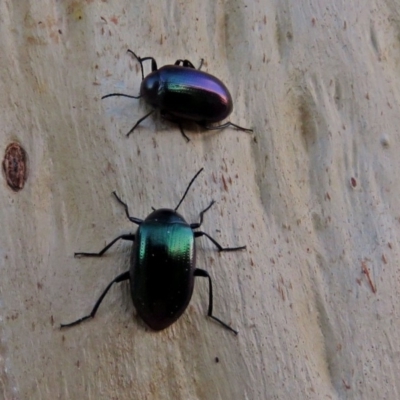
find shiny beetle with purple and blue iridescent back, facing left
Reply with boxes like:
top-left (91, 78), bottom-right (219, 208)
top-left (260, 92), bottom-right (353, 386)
top-left (102, 50), bottom-right (253, 141)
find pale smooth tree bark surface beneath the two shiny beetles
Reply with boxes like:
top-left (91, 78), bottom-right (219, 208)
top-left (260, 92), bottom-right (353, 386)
top-left (0, 0), bottom-right (400, 400)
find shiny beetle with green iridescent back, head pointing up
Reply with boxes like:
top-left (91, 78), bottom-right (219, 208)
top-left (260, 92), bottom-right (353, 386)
top-left (61, 168), bottom-right (246, 334)
